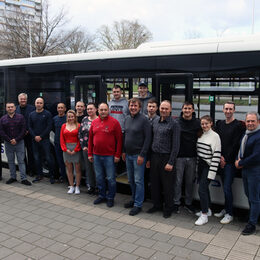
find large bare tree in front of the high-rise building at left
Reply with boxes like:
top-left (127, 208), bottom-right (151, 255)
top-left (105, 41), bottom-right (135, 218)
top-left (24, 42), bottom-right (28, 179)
top-left (0, 0), bottom-right (96, 58)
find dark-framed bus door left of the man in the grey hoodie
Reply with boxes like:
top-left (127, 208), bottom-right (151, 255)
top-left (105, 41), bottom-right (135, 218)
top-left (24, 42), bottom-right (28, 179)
top-left (75, 75), bottom-right (107, 105)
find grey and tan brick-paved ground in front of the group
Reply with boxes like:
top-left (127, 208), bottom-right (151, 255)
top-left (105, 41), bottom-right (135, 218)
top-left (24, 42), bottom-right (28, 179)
top-left (0, 170), bottom-right (260, 260)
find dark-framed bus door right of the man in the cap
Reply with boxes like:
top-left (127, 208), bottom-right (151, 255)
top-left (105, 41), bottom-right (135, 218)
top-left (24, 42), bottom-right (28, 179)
top-left (153, 73), bottom-right (193, 117)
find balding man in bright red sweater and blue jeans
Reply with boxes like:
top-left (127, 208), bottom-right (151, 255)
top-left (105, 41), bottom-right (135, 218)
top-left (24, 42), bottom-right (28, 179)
top-left (88, 103), bottom-right (122, 207)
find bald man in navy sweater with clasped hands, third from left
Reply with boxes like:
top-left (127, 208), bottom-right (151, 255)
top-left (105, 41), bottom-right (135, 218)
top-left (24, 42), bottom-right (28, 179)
top-left (29, 97), bottom-right (54, 184)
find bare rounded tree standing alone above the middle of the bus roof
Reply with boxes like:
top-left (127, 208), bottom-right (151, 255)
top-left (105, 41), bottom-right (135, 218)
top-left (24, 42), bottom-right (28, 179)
top-left (97, 20), bottom-right (152, 50)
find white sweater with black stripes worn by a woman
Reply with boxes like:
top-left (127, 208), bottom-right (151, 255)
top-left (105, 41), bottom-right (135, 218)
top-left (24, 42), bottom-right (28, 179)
top-left (197, 129), bottom-right (221, 180)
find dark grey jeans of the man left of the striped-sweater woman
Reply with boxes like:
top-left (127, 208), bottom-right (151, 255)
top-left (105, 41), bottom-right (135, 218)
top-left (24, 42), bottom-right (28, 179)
top-left (174, 157), bottom-right (197, 205)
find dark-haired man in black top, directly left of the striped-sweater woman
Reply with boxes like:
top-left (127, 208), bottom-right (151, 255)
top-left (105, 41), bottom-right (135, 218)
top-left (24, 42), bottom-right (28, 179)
top-left (174, 101), bottom-right (201, 213)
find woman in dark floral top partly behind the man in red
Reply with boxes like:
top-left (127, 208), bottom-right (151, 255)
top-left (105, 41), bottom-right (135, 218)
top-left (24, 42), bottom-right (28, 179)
top-left (79, 103), bottom-right (97, 194)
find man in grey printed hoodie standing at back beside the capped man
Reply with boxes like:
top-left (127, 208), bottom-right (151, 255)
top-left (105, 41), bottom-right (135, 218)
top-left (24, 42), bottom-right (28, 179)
top-left (108, 85), bottom-right (129, 132)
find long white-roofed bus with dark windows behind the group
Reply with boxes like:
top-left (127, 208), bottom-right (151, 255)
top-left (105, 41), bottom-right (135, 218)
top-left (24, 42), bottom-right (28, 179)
top-left (0, 35), bottom-right (260, 208)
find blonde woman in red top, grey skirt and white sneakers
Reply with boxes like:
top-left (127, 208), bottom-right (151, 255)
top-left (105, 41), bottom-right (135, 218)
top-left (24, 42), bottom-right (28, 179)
top-left (60, 110), bottom-right (81, 194)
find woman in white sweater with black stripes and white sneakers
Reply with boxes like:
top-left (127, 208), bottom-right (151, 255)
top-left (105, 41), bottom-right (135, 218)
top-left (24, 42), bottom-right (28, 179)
top-left (195, 115), bottom-right (221, 226)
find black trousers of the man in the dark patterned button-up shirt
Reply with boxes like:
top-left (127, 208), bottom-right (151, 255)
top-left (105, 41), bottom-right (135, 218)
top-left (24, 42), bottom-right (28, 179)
top-left (150, 153), bottom-right (174, 211)
